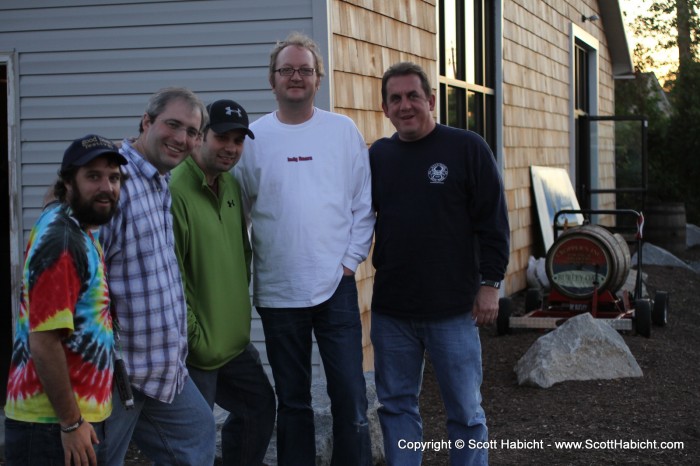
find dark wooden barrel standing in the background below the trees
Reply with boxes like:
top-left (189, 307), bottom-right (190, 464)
top-left (643, 202), bottom-right (686, 254)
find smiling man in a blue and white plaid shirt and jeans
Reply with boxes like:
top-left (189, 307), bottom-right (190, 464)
top-left (100, 88), bottom-right (216, 465)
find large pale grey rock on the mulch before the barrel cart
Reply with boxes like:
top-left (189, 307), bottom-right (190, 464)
top-left (514, 313), bottom-right (642, 388)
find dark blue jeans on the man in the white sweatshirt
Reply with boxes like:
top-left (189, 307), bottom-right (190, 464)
top-left (258, 276), bottom-right (372, 466)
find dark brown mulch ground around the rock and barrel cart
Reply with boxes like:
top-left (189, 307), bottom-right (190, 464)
top-left (420, 247), bottom-right (700, 465)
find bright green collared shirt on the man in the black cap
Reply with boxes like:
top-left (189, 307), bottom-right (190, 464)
top-left (170, 157), bottom-right (251, 370)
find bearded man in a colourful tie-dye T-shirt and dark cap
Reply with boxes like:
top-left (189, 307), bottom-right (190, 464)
top-left (5, 134), bottom-right (127, 465)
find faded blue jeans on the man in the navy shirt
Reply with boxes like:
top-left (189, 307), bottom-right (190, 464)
top-left (371, 312), bottom-right (488, 466)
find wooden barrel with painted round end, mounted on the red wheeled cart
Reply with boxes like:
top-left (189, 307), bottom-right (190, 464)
top-left (545, 225), bottom-right (632, 299)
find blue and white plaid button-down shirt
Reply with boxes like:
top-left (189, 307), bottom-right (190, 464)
top-left (100, 140), bottom-right (187, 403)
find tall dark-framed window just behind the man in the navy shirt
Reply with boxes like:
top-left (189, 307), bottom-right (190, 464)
top-left (438, 0), bottom-right (496, 149)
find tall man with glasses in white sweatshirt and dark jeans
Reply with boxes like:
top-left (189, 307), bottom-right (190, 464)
top-left (236, 33), bottom-right (374, 466)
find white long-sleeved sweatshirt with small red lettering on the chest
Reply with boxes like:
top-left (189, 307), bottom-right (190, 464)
top-left (235, 108), bottom-right (375, 308)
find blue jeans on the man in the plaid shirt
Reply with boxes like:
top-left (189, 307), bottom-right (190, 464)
top-left (102, 378), bottom-right (216, 466)
